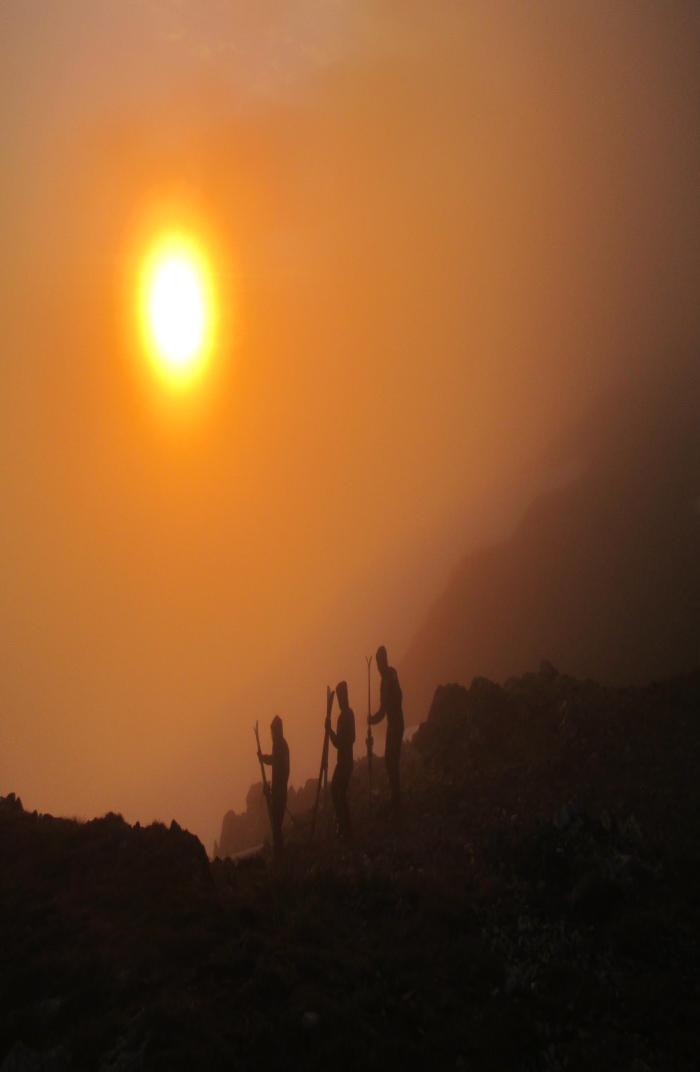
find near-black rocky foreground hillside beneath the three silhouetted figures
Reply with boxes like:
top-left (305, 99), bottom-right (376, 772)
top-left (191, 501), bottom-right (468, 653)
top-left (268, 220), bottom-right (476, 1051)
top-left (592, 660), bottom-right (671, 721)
top-left (0, 666), bottom-right (700, 1072)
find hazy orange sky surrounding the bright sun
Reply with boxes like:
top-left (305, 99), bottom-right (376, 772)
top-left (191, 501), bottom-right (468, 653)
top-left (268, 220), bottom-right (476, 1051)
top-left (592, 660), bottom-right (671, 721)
top-left (0, 0), bottom-right (700, 847)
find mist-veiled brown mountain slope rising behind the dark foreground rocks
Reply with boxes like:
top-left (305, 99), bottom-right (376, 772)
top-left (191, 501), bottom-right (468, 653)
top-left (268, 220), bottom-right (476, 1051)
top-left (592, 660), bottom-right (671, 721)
top-left (402, 362), bottom-right (700, 717)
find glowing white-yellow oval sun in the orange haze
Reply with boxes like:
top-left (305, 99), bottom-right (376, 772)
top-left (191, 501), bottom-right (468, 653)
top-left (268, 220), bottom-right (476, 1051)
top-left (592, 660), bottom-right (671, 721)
top-left (139, 234), bottom-right (215, 387)
